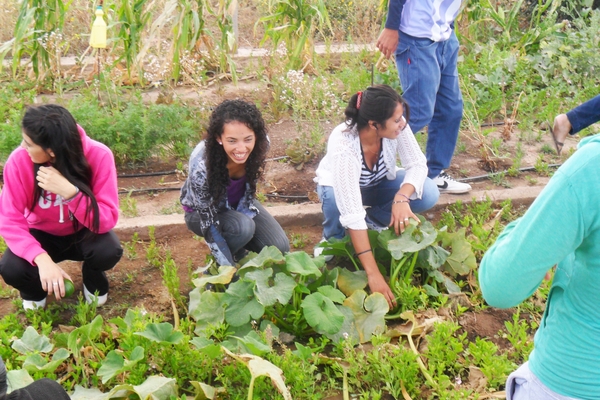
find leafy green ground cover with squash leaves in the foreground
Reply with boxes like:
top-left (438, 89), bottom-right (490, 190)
top-left (0, 201), bottom-right (544, 399)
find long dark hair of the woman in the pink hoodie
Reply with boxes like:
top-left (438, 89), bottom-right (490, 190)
top-left (21, 104), bottom-right (100, 233)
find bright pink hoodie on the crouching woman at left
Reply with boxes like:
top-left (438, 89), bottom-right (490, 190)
top-left (0, 125), bottom-right (119, 265)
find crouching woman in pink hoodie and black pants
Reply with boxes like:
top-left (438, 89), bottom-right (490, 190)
top-left (0, 104), bottom-right (123, 309)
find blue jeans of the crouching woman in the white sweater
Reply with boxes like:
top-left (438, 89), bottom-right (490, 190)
top-left (317, 170), bottom-right (440, 239)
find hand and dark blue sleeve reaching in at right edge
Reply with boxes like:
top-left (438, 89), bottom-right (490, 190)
top-left (552, 95), bottom-right (600, 155)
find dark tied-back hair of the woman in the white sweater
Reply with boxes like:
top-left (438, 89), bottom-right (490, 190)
top-left (344, 85), bottom-right (410, 131)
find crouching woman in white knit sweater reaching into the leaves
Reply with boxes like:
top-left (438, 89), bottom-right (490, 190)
top-left (315, 85), bottom-right (439, 307)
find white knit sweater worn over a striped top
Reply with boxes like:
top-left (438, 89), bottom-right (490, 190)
top-left (314, 123), bottom-right (427, 230)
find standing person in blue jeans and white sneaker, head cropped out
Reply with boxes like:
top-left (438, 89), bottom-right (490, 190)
top-left (377, 0), bottom-right (471, 194)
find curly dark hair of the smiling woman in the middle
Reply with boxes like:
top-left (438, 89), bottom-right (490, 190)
top-left (205, 100), bottom-right (269, 205)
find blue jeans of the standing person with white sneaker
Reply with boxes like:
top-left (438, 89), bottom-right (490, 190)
top-left (396, 32), bottom-right (463, 178)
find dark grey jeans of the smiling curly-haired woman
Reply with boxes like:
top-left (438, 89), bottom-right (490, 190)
top-left (185, 200), bottom-right (290, 258)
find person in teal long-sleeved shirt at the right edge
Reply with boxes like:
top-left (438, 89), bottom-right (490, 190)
top-left (479, 135), bottom-right (600, 400)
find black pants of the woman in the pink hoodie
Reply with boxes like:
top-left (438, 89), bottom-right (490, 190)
top-left (0, 228), bottom-right (123, 301)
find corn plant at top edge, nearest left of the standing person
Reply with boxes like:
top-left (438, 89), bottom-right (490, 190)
top-left (255, 0), bottom-right (332, 68)
